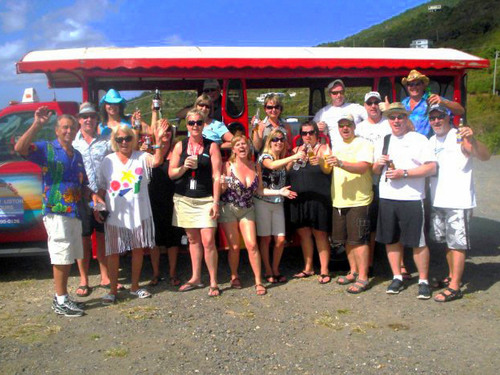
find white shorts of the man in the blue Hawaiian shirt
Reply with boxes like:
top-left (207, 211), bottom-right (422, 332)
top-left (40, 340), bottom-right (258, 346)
top-left (43, 214), bottom-right (83, 265)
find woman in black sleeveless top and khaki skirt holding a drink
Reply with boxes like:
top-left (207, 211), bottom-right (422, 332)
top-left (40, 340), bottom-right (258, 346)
top-left (168, 109), bottom-right (221, 297)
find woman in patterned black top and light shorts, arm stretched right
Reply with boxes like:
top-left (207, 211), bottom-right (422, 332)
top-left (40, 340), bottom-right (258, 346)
top-left (254, 129), bottom-right (306, 283)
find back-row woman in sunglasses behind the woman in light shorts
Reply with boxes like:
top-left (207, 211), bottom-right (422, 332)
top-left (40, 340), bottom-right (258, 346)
top-left (252, 94), bottom-right (292, 152)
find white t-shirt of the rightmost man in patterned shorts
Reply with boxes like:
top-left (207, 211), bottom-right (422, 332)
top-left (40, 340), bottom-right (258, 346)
top-left (429, 128), bottom-right (476, 209)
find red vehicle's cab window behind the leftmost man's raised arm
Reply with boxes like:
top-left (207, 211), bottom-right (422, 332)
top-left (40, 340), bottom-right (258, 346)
top-left (0, 111), bottom-right (57, 162)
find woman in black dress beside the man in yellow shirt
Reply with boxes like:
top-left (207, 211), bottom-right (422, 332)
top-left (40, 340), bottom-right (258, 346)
top-left (289, 121), bottom-right (332, 284)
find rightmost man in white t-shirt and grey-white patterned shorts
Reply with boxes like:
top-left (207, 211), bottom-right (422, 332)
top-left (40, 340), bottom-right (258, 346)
top-left (429, 104), bottom-right (490, 302)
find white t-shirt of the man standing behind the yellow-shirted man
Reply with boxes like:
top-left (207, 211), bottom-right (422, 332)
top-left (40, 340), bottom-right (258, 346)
top-left (313, 103), bottom-right (368, 148)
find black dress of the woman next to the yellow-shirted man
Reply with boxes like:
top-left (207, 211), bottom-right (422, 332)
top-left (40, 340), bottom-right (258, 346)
top-left (288, 163), bottom-right (332, 232)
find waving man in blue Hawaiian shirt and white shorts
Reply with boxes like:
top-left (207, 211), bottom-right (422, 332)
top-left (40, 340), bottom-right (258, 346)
top-left (15, 107), bottom-right (104, 317)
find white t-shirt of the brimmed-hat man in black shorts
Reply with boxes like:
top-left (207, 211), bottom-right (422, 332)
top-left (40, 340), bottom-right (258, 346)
top-left (375, 131), bottom-right (436, 201)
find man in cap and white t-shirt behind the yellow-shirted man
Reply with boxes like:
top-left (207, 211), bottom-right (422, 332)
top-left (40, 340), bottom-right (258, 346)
top-left (314, 79), bottom-right (367, 147)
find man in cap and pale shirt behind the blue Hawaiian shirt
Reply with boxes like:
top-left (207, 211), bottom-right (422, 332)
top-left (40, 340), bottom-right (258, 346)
top-left (73, 102), bottom-right (112, 297)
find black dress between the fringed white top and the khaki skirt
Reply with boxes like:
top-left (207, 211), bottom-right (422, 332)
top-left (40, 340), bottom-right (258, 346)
top-left (149, 159), bottom-right (184, 248)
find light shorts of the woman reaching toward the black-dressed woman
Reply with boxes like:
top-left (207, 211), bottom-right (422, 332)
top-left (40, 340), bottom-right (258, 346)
top-left (253, 198), bottom-right (285, 237)
